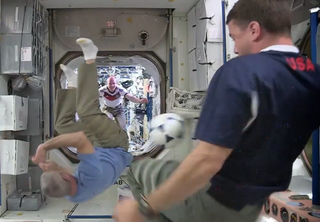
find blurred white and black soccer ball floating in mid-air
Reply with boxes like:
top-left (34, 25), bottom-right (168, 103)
top-left (149, 113), bottom-right (185, 147)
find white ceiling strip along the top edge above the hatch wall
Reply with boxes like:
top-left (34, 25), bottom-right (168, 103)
top-left (39, 0), bottom-right (198, 12)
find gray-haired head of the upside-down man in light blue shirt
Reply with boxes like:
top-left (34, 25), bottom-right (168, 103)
top-left (40, 171), bottom-right (72, 198)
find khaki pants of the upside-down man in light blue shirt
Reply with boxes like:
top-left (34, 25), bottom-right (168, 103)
top-left (54, 63), bottom-right (129, 150)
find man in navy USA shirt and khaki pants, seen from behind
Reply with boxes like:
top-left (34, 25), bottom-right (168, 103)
top-left (115, 0), bottom-right (320, 222)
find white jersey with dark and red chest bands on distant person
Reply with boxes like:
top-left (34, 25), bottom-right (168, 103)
top-left (99, 86), bottom-right (128, 108)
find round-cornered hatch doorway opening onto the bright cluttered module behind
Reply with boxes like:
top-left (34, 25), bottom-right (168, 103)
top-left (55, 52), bottom-right (166, 163)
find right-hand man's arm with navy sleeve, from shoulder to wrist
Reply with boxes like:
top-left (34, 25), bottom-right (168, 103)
top-left (146, 62), bottom-right (254, 212)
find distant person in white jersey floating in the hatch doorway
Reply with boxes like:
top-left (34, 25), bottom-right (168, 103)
top-left (99, 76), bottom-right (148, 131)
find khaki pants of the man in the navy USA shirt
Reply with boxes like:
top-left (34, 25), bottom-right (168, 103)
top-left (121, 158), bottom-right (262, 222)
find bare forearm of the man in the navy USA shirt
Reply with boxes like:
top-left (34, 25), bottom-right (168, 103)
top-left (147, 141), bottom-right (232, 212)
